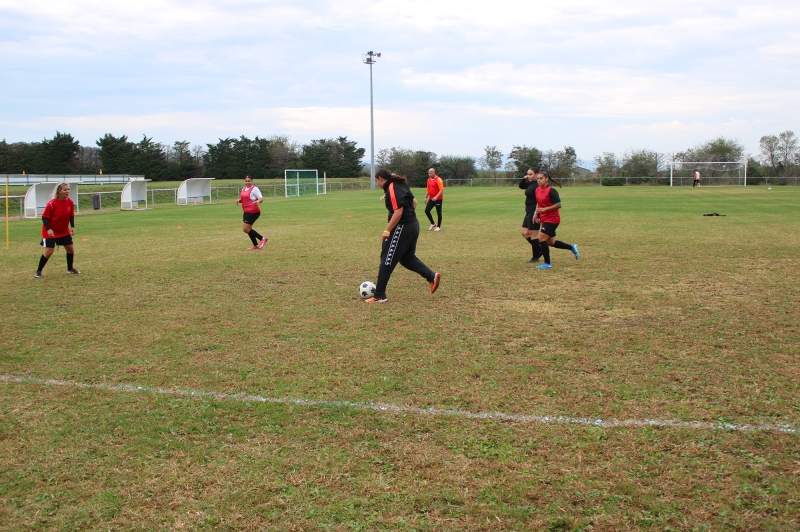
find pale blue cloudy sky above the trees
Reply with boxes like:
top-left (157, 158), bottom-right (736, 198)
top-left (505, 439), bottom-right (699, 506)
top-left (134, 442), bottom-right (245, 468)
top-left (0, 0), bottom-right (800, 163)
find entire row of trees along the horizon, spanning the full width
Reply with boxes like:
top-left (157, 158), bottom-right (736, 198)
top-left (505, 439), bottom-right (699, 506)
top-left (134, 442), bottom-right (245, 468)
top-left (0, 131), bottom-right (800, 186)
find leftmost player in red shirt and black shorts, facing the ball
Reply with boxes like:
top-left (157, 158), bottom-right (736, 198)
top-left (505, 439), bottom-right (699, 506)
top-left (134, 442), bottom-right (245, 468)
top-left (35, 183), bottom-right (80, 279)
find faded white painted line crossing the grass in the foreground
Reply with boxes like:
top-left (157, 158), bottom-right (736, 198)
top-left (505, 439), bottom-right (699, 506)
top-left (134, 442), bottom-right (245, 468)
top-left (0, 375), bottom-right (798, 434)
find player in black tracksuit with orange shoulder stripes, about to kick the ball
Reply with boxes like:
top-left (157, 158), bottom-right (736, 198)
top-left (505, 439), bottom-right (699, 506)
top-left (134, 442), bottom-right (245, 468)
top-left (365, 168), bottom-right (442, 303)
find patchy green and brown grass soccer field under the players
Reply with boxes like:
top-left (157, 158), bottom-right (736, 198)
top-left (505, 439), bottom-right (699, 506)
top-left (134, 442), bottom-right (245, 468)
top-left (0, 187), bottom-right (800, 530)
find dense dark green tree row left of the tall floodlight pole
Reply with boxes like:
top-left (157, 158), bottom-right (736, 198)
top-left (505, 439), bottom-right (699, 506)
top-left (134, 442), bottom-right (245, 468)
top-left (0, 132), bottom-right (364, 181)
